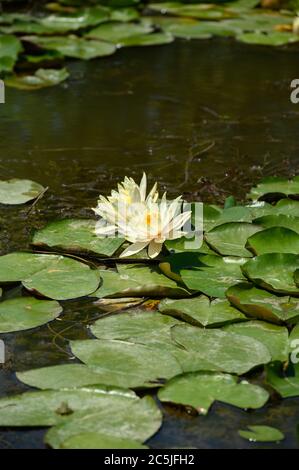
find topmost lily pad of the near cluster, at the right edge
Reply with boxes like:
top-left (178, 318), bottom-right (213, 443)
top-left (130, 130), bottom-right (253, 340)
top-left (248, 174), bottom-right (299, 201)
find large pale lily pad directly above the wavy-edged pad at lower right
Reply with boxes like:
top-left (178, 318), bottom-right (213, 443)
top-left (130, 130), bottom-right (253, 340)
top-left (171, 325), bottom-right (271, 375)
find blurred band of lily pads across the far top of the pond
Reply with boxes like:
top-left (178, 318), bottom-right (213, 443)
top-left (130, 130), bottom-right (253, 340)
top-left (0, 0), bottom-right (299, 90)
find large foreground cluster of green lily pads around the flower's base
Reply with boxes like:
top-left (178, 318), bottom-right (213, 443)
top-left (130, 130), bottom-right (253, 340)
top-left (0, 174), bottom-right (299, 448)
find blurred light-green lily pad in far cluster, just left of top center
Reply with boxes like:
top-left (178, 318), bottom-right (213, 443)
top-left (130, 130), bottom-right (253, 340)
top-left (85, 22), bottom-right (153, 44)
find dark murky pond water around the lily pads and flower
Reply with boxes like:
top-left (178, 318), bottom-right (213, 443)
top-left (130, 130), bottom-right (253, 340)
top-left (0, 40), bottom-right (299, 448)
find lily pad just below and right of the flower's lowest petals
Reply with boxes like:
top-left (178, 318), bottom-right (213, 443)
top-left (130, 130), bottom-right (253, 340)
top-left (179, 255), bottom-right (246, 298)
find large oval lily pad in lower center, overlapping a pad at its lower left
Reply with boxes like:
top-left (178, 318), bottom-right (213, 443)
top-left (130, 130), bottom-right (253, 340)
top-left (71, 339), bottom-right (182, 388)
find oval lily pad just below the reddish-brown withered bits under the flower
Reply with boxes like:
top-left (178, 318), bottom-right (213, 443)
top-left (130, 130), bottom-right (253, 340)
top-left (91, 310), bottom-right (181, 346)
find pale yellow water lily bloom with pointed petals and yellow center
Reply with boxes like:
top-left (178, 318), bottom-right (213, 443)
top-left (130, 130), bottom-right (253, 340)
top-left (94, 174), bottom-right (191, 258)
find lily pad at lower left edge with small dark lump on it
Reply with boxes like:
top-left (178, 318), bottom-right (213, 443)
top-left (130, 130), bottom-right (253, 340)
top-left (0, 387), bottom-right (139, 430)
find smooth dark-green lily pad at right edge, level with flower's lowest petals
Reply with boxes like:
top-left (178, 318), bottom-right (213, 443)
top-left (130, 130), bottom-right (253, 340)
top-left (246, 227), bottom-right (299, 255)
